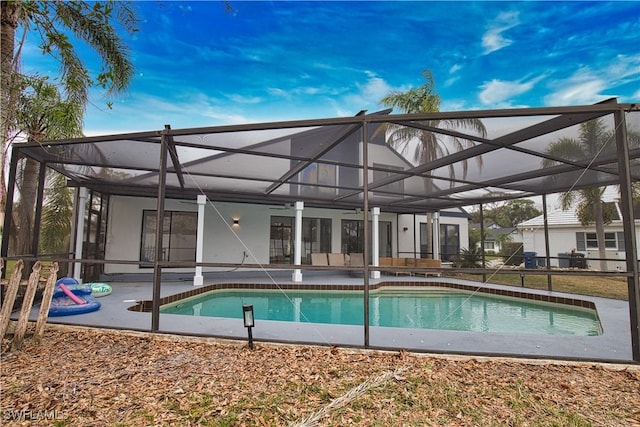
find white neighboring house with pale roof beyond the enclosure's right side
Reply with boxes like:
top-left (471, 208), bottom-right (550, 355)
top-left (517, 190), bottom-right (640, 271)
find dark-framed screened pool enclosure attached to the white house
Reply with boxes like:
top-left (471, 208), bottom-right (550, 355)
top-left (1, 99), bottom-right (640, 361)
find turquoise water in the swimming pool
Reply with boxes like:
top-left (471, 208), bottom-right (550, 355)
top-left (161, 289), bottom-right (602, 336)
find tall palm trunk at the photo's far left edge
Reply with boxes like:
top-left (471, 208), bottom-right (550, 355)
top-left (0, 1), bottom-right (21, 214)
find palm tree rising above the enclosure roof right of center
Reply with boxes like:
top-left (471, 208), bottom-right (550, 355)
top-left (380, 70), bottom-right (487, 260)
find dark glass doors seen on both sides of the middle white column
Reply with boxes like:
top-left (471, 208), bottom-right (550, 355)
top-left (269, 216), bottom-right (331, 264)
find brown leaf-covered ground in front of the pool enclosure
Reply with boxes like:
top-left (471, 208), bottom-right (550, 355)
top-left (0, 326), bottom-right (640, 426)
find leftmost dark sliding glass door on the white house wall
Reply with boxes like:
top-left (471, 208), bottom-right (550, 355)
top-left (140, 210), bottom-right (198, 268)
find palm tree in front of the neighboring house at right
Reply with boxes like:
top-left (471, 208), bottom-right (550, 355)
top-left (542, 119), bottom-right (640, 271)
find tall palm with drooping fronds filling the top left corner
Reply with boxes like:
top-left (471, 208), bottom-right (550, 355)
top-left (0, 0), bottom-right (137, 217)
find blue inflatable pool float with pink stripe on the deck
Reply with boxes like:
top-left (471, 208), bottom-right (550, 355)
top-left (49, 277), bottom-right (101, 317)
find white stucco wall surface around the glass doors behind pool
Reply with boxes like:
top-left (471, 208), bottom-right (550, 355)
top-left (105, 196), bottom-right (469, 273)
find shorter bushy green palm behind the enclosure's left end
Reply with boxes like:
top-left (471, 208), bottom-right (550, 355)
top-left (13, 76), bottom-right (83, 260)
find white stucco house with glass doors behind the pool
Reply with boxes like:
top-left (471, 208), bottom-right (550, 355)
top-left (104, 196), bottom-right (468, 274)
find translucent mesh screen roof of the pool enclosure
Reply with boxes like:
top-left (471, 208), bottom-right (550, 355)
top-left (13, 100), bottom-right (640, 213)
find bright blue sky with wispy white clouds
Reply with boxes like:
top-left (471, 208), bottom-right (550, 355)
top-left (23, 1), bottom-right (640, 135)
